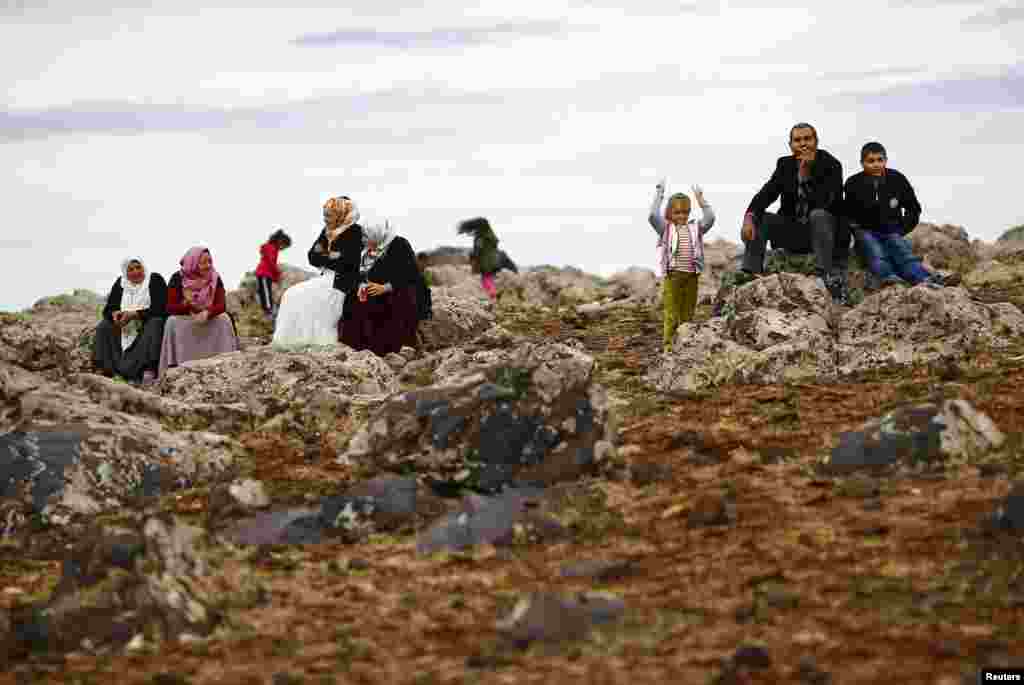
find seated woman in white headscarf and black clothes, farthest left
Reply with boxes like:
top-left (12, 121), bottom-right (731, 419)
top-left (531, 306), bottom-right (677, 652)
top-left (92, 258), bottom-right (167, 385)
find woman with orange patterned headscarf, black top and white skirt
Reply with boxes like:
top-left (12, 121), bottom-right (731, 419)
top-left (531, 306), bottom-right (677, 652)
top-left (271, 196), bottom-right (362, 345)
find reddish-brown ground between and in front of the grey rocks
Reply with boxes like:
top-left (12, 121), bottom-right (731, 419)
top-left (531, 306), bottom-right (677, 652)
top-left (0, 296), bottom-right (1024, 685)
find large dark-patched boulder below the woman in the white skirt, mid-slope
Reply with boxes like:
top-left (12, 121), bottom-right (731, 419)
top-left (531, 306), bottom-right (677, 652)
top-left (340, 344), bottom-right (613, 491)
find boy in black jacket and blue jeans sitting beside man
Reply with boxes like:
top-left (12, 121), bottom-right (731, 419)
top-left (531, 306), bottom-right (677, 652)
top-left (843, 141), bottom-right (957, 290)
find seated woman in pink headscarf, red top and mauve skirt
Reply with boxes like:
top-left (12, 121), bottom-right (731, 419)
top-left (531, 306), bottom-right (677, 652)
top-left (160, 248), bottom-right (239, 376)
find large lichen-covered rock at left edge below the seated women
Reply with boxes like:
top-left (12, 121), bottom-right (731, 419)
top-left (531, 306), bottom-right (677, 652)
top-left (0, 363), bottom-right (233, 532)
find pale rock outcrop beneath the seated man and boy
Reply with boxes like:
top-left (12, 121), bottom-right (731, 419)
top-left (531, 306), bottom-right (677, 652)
top-left (647, 273), bottom-right (1024, 391)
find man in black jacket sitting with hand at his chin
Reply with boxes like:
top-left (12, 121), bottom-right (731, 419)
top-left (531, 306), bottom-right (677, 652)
top-left (739, 123), bottom-right (850, 305)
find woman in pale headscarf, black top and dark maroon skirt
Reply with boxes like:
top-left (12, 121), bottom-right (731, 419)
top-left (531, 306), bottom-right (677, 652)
top-left (341, 223), bottom-right (420, 356)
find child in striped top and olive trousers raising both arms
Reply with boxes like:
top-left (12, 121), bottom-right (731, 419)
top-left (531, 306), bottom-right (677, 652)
top-left (647, 179), bottom-right (715, 352)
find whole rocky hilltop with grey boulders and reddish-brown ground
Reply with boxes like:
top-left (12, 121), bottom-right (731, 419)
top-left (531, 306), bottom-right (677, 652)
top-left (0, 224), bottom-right (1024, 685)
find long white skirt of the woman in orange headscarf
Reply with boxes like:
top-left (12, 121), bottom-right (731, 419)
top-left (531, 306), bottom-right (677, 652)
top-left (271, 271), bottom-right (345, 346)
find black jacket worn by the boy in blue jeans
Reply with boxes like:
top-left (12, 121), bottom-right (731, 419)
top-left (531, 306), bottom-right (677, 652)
top-left (843, 169), bottom-right (921, 236)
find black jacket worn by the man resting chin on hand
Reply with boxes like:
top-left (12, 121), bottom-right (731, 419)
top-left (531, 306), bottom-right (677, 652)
top-left (746, 149), bottom-right (843, 223)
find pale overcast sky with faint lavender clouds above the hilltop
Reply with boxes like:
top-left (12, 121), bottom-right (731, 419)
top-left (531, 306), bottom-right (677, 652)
top-left (0, 0), bottom-right (1024, 309)
